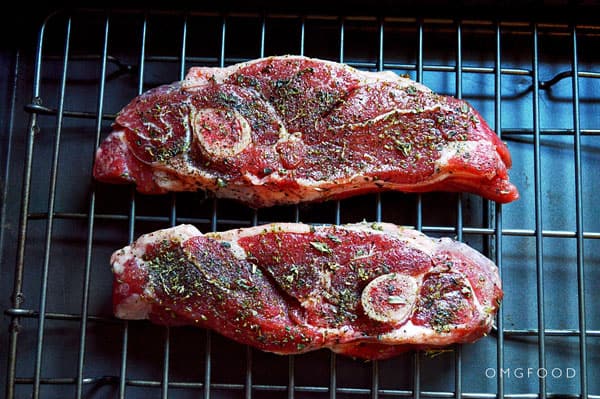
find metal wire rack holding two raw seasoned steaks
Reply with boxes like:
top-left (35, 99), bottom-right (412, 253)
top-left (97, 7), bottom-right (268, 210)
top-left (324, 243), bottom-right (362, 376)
top-left (5, 6), bottom-right (600, 399)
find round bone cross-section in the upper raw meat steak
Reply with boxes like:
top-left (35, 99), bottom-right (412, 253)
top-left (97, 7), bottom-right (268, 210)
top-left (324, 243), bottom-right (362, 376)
top-left (192, 108), bottom-right (252, 159)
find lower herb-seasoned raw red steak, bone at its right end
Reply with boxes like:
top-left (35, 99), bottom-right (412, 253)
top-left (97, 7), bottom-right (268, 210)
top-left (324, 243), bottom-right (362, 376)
top-left (111, 223), bottom-right (503, 359)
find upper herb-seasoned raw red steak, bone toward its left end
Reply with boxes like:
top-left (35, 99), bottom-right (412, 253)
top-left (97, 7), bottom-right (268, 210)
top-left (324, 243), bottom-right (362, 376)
top-left (94, 56), bottom-right (519, 208)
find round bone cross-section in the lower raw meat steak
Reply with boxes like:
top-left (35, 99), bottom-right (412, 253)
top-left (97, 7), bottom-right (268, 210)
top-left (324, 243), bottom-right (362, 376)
top-left (361, 273), bottom-right (419, 324)
